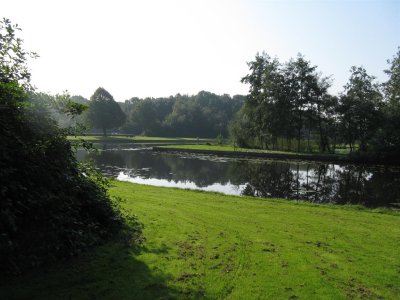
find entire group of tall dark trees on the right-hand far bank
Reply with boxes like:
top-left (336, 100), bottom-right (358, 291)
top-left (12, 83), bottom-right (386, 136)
top-left (230, 48), bottom-right (400, 161)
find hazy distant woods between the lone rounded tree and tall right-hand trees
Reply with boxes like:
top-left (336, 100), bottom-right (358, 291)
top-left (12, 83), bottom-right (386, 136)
top-left (121, 91), bottom-right (243, 138)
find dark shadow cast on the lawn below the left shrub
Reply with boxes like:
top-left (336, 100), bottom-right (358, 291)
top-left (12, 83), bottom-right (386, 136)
top-left (0, 244), bottom-right (201, 300)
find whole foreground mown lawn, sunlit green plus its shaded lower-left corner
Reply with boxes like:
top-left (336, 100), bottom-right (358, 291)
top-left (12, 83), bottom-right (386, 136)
top-left (0, 182), bottom-right (400, 299)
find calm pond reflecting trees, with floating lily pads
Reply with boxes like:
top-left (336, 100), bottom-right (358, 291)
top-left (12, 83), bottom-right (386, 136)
top-left (77, 143), bottom-right (400, 207)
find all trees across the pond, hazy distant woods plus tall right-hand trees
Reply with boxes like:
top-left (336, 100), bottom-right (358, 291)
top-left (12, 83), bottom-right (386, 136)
top-left (43, 48), bottom-right (400, 160)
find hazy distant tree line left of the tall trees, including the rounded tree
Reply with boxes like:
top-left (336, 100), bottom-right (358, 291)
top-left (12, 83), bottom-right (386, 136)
top-left (61, 87), bottom-right (245, 138)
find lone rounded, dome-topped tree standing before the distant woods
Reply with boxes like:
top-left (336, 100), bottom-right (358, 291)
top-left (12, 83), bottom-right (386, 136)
top-left (88, 87), bottom-right (126, 136)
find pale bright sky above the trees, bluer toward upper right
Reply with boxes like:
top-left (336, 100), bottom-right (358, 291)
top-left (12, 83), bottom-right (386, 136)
top-left (0, 0), bottom-right (400, 101)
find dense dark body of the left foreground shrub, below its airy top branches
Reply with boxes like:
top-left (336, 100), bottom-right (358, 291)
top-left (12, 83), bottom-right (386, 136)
top-left (0, 82), bottom-right (135, 273)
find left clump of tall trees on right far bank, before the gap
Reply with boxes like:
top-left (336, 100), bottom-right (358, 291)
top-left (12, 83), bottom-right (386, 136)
top-left (238, 53), bottom-right (334, 152)
